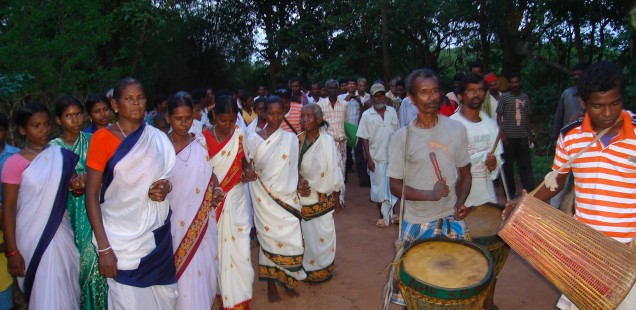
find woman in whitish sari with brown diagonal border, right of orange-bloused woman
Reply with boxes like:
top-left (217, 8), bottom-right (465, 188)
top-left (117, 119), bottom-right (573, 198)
top-left (166, 95), bottom-right (223, 309)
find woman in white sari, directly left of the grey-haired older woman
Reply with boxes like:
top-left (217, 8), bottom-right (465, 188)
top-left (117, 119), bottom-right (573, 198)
top-left (247, 96), bottom-right (306, 302)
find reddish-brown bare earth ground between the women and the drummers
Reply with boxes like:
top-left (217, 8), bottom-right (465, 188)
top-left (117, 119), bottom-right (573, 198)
top-left (252, 173), bottom-right (560, 310)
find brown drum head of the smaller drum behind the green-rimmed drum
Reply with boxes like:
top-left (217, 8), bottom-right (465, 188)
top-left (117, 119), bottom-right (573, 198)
top-left (464, 204), bottom-right (503, 238)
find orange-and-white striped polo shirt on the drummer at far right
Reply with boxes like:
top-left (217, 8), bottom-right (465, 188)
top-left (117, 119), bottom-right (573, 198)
top-left (552, 111), bottom-right (636, 243)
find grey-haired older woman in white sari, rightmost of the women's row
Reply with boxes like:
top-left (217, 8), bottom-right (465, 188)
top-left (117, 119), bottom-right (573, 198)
top-left (298, 104), bottom-right (344, 282)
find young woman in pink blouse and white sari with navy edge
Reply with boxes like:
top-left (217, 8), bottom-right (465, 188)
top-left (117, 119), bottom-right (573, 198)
top-left (2, 103), bottom-right (81, 309)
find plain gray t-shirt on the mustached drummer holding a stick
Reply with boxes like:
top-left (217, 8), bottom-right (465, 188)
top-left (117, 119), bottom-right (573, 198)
top-left (387, 115), bottom-right (470, 224)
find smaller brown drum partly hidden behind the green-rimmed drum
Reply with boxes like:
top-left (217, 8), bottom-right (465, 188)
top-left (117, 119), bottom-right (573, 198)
top-left (464, 203), bottom-right (510, 277)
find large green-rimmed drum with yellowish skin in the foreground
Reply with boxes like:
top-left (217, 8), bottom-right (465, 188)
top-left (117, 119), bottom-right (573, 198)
top-left (397, 238), bottom-right (493, 310)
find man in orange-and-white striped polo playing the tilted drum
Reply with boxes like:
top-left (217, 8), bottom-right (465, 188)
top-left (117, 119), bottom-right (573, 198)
top-left (507, 62), bottom-right (636, 310)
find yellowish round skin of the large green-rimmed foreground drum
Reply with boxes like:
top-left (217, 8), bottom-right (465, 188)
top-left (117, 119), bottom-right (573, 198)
top-left (403, 240), bottom-right (492, 289)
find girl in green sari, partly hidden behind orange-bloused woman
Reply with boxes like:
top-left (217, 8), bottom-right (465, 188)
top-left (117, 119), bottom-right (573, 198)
top-left (49, 96), bottom-right (110, 309)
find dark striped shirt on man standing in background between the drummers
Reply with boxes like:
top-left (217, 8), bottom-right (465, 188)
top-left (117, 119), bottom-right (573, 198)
top-left (497, 92), bottom-right (532, 138)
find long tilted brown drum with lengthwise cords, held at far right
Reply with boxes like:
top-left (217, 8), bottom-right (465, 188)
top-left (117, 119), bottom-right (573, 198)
top-left (499, 195), bottom-right (636, 309)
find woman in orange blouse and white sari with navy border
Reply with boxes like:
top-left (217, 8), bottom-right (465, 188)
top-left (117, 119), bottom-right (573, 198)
top-left (86, 78), bottom-right (177, 309)
